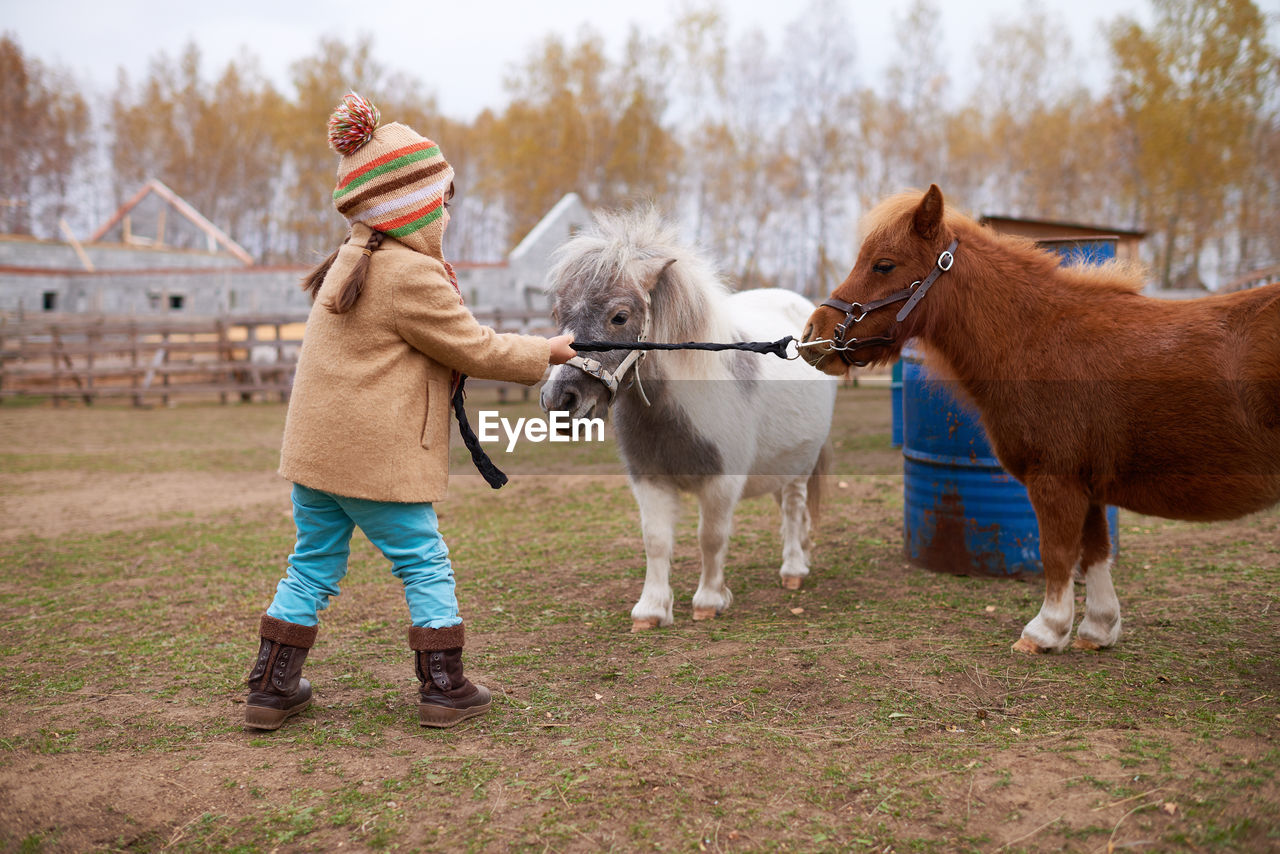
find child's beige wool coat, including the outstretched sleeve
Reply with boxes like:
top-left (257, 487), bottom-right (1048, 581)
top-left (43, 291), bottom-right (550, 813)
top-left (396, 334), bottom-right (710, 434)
top-left (280, 223), bottom-right (550, 502)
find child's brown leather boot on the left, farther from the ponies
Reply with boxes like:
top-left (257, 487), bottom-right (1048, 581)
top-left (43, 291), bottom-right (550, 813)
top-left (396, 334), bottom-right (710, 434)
top-left (244, 613), bottom-right (319, 730)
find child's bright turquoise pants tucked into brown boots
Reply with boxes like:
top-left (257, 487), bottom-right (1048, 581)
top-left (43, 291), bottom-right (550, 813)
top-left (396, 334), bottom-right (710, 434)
top-left (266, 484), bottom-right (462, 629)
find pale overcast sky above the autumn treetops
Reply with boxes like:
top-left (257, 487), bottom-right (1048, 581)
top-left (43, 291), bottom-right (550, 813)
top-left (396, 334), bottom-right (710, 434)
top-left (0, 0), bottom-right (1187, 119)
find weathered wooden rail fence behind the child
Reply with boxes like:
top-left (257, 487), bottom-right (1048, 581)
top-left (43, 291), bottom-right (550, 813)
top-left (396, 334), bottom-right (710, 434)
top-left (0, 311), bottom-right (552, 406)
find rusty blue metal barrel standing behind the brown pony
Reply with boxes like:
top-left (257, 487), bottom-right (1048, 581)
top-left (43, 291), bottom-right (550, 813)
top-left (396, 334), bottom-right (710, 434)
top-left (902, 238), bottom-right (1119, 576)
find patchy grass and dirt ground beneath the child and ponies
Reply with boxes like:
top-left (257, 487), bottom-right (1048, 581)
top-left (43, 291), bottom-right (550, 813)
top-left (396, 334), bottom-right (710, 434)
top-left (0, 396), bottom-right (1280, 851)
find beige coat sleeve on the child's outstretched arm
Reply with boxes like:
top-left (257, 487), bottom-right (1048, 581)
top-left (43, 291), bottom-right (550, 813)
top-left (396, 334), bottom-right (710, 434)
top-left (393, 256), bottom-right (550, 385)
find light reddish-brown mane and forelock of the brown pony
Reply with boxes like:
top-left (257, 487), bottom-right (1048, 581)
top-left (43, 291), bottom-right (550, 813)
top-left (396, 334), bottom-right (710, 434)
top-left (860, 189), bottom-right (1147, 293)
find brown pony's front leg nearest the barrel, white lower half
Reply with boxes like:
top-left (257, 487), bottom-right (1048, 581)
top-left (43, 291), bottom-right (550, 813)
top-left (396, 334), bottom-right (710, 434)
top-left (1014, 475), bottom-right (1089, 653)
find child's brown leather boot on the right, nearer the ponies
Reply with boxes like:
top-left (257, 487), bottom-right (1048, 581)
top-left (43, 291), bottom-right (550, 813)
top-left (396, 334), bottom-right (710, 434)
top-left (408, 624), bottom-right (489, 726)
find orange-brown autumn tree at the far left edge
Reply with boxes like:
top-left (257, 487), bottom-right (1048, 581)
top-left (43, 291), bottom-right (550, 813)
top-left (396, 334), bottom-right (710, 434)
top-left (0, 35), bottom-right (91, 237)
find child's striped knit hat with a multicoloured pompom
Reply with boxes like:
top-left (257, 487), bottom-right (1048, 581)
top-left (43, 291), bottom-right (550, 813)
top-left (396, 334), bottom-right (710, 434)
top-left (329, 92), bottom-right (453, 260)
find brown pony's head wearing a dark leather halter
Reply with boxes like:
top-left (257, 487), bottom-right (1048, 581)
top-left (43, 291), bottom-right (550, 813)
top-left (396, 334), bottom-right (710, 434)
top-left (800, 184), bottom-right (954, 376)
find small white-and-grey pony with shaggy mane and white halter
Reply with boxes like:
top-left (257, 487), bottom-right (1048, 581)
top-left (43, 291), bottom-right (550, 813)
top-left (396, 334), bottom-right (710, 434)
top-left (541, 209), bottom-right (836, 631)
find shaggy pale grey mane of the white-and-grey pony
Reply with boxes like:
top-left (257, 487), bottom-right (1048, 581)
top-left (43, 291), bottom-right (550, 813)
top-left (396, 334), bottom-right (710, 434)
top-left (547, 205), bottom-right (730, 341)
